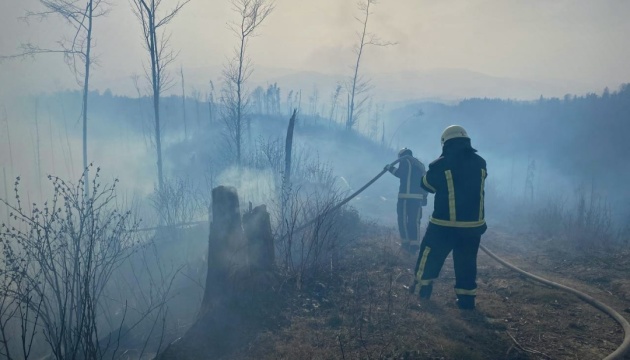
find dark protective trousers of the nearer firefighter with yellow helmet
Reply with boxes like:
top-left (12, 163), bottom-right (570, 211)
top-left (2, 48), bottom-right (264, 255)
top-left (412, 223), bottom-right (481, 309)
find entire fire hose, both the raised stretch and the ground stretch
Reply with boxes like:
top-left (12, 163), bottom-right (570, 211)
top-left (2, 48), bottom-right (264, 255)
top-left (295, 156), bottom-right (630, 360)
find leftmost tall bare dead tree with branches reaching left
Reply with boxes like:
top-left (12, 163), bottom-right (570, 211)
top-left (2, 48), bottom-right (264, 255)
top-left (0, 0), bottom-right (108, 193)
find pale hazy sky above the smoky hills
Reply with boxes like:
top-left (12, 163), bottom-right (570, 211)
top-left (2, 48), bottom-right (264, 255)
top-left (0, 0), bottom-right (630, 95)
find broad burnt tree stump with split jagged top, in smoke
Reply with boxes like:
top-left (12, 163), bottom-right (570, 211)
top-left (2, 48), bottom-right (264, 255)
top-left (159, 186), bottom-right (281, 360)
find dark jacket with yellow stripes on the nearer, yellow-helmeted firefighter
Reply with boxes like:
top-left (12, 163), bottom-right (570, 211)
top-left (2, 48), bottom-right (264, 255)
top-left (422, 138), bottom-right (487, 230)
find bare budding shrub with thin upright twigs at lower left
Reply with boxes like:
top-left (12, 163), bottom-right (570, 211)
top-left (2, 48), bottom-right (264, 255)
top-left (0, 169), bottom-right (137, 359)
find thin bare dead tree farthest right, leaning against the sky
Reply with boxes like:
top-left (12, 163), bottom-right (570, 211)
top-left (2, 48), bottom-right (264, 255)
top-left (346, 0), bottom-right (395, 130)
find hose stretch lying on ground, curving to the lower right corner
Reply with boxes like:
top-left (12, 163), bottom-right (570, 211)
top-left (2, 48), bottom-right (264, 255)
top-left (479, 245), bottom-right (630, 360)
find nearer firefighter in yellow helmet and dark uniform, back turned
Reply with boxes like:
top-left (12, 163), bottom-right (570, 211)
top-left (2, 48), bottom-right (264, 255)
top-left (410, 125), bottom-right (487, 309)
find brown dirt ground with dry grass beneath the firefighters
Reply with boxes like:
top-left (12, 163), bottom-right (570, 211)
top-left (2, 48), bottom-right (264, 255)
top-left (166, 229), bottom-right (630, 360)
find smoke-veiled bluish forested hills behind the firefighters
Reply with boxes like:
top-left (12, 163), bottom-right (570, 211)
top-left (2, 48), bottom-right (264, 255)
top-left (7, 84), bottom-right (630, 219)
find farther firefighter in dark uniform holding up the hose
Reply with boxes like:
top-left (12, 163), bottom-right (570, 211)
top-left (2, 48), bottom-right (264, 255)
top-left (385, 148), bottom-right (427, 251)
